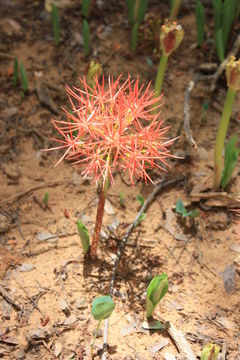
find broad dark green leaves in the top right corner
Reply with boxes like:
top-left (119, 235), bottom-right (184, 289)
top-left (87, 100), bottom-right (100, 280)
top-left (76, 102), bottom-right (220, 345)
top-left (213, 0), bottom-right (239, 62)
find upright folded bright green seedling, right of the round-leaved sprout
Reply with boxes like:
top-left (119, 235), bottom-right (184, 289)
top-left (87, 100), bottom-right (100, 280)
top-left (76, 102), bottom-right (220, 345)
top-left (146, 273), bottom-right (168, 319)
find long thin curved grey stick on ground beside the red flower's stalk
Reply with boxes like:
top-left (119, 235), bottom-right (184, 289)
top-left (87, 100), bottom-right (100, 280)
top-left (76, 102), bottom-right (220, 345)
top-left (102, 176), bottom-right (185, 360)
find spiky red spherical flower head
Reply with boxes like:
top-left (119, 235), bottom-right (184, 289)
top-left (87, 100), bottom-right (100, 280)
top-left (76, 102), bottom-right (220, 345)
top-left (47, 76), bottom-right (174, 185)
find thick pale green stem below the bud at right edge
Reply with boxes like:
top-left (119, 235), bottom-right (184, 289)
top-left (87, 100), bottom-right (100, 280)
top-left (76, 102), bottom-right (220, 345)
top-left (214, 88), bottom-right (236, 189)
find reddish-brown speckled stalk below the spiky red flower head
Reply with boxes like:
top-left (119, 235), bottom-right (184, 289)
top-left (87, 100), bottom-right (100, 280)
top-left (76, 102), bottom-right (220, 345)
top-left (90, 186), bottom-right (106, 257)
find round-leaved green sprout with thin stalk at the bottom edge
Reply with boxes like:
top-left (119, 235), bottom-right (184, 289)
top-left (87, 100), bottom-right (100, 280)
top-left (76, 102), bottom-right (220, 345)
top-left (91, 295), bottom-right (115, 360)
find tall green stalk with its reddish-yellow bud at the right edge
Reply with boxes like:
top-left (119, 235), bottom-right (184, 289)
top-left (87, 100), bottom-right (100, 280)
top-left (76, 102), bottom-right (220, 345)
top-left (214, 56), bottom-right (240, 189)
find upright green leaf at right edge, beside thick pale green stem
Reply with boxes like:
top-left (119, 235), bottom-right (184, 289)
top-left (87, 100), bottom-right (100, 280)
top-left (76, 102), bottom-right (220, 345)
top-left (221, 135), bottom-right (240, 189)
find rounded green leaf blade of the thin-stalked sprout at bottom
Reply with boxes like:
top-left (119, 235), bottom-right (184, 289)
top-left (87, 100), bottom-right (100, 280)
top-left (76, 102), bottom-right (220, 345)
top-left (92, 295), bottom-right (115, 320)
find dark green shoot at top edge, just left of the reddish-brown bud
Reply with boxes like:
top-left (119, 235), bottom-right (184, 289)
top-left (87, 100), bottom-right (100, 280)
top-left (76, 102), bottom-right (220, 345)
top-left (127, 0), bottom-right (147, 52)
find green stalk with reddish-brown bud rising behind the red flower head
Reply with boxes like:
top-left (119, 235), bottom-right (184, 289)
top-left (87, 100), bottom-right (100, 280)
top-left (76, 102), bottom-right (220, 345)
top-left (154, 21), bottom-right (184, 100)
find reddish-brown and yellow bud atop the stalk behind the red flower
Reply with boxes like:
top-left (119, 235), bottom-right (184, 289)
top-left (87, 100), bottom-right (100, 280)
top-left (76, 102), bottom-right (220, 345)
top-left (160, 21), bottom-right (184, 56)
